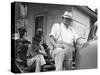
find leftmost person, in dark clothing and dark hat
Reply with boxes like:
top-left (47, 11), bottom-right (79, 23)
top-left (16, 27), bottom-right (30, 62)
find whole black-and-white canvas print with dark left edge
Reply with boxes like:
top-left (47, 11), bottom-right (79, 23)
top-left (11, 2), bottom-right (98, 73)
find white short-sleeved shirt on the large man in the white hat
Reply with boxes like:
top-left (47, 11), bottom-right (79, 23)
top-left (50, 23), bottom-right (79, 45)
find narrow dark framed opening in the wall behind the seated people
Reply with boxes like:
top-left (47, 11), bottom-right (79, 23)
top-left (34, 12), bottom-right (47, 40)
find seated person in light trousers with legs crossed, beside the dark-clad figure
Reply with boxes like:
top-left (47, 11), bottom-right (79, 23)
top-left (27, 29), bottom-right (46, 72)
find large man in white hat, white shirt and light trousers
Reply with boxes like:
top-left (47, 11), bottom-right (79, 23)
top-left (50, 11), bottom-right (82, 71)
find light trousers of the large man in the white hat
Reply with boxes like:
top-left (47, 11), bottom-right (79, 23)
top-left (52, 46), bottom-right (74, 71)
